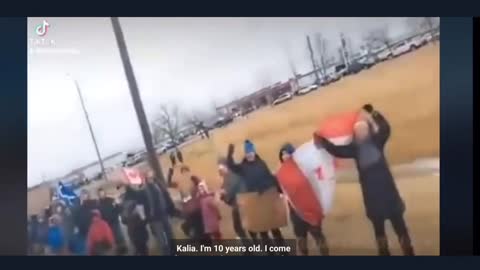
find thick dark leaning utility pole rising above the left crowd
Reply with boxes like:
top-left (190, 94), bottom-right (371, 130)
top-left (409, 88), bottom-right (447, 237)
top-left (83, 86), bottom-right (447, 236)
top-left (111, 17), bottom-right (169, 189)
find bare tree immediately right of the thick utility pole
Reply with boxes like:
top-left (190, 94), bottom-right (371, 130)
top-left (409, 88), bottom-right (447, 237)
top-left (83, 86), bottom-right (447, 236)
top-left (151, 104), bottom-right (182, 147)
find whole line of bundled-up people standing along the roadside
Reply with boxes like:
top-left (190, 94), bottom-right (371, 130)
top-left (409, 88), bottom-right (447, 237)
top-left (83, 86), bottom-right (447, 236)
top-left (28, 104), bottom-right (414, 255)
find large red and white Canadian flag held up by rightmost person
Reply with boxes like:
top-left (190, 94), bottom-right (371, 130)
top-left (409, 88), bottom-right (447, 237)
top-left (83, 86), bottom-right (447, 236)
top-left (277, 109), bottom-right (358, 225)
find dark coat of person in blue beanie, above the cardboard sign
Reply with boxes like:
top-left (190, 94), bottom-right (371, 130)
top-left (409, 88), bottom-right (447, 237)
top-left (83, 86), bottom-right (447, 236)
top-left (227, 155), bottom-right (278, 193)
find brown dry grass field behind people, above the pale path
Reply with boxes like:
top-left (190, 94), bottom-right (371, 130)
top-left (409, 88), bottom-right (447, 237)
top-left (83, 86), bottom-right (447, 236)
top-left (160, 45), bottom-right (440, 190)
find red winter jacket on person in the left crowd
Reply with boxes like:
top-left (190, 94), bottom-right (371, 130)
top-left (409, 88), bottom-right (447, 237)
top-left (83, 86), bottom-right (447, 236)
top-left (87, 210), bottom-right (115, 255)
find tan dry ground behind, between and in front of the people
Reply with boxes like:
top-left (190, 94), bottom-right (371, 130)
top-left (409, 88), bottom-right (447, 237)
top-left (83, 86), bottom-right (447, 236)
top-left (29, 44), bottom-right (440, 255)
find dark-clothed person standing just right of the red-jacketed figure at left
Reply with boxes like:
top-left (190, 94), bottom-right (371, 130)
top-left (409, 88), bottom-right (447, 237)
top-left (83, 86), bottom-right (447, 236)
top-left (98, 188), bottom-right (127, 255)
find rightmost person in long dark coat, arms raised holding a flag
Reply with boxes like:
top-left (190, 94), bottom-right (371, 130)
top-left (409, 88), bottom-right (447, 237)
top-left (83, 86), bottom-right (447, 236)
top-left (314, 104), bottom-right (414, 256)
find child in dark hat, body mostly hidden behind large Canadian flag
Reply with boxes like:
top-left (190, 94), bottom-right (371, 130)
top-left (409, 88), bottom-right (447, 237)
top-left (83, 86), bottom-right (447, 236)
top-left (279, 143), bottom-right (329, 256)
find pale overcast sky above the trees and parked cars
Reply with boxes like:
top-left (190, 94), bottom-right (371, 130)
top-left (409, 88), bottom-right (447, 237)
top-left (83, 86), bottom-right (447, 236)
top-left (28, 18), bottom-right (408, 186)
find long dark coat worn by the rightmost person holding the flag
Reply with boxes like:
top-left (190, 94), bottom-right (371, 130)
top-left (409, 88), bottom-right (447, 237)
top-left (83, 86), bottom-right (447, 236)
top-left (322, 112), bottom-right (405, 219)
